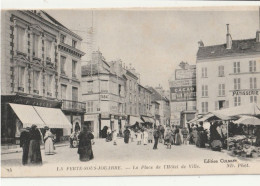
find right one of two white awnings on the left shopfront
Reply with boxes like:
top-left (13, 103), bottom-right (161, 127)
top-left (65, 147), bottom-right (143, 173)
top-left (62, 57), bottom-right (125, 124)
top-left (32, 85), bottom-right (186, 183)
top-left (34, 106), bottom-right (72, 128)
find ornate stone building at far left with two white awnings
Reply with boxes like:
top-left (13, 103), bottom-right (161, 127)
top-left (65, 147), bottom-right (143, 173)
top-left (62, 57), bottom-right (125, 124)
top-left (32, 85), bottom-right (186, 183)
top-left (1, 10), bottom-right (84, 144)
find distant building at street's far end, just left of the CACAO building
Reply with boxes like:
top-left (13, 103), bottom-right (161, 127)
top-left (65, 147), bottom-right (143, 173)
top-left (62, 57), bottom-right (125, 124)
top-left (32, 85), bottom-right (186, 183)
top-left (148, 86), bottom-right (171, 126)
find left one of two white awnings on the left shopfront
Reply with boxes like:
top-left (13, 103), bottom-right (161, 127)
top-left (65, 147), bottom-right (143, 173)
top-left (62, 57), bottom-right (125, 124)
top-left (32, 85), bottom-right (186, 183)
top-left (9, 103), bottom-right (46, 128)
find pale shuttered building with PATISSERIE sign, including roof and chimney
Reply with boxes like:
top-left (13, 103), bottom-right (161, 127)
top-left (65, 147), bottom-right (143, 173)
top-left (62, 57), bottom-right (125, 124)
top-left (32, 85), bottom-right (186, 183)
top-left (196, 25), bottom-right (260, 114)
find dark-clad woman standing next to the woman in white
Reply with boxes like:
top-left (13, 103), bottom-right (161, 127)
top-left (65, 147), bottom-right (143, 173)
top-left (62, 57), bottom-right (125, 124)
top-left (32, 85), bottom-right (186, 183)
top-left (28, 125), bottom-right (42, 165)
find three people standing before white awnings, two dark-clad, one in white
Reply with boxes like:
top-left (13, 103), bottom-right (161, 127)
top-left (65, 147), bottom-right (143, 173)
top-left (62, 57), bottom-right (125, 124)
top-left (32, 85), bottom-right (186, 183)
top-left (20, 125), bottom-right (55, 165)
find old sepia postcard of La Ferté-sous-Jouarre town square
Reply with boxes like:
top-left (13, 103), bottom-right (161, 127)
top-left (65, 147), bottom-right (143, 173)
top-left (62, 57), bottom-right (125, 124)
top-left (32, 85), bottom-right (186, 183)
top-left (1, 6), bottom-right (260, 177)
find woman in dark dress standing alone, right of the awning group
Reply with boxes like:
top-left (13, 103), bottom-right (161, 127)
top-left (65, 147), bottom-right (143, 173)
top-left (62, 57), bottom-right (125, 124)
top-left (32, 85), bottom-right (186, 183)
top-left (78, 126), bottom-right (94, 161)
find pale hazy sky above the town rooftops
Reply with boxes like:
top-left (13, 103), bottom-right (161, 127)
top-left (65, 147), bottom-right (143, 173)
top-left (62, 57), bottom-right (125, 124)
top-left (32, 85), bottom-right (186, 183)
top-left (47, 7), bottom-right (259, 90)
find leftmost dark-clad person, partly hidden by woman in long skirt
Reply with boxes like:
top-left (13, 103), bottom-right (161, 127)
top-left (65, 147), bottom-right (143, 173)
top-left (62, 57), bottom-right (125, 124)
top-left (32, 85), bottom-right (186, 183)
top-left (20, 127), bottom-right (30, 165)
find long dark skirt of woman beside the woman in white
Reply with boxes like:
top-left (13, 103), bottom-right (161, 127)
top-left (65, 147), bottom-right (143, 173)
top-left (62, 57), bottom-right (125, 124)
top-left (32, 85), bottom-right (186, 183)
top-left (28, 140), bottom-right (42, 165)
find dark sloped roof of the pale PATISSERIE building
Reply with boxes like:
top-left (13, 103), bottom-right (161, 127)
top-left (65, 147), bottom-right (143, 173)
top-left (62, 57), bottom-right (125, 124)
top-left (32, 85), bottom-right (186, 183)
top-left (197, 38), bottom-right (260, 59)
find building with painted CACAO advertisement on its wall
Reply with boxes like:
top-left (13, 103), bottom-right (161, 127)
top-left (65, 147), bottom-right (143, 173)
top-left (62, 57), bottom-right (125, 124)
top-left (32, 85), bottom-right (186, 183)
top-left (169, 62), bottom-right (196, 127)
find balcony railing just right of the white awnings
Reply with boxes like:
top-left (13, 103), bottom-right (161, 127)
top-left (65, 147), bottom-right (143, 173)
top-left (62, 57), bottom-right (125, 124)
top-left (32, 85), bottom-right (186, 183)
top-left (61, 100), bottom-right (86, 112)
